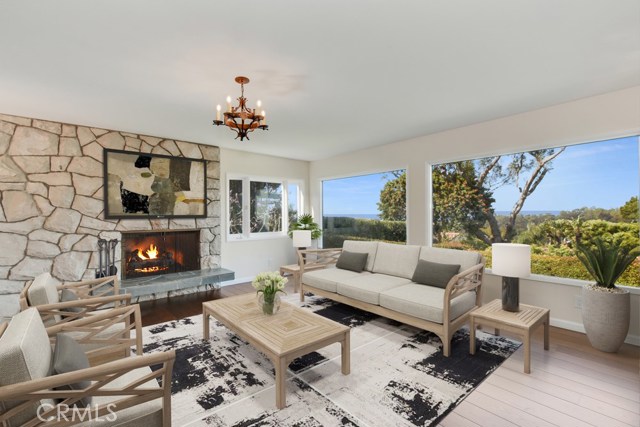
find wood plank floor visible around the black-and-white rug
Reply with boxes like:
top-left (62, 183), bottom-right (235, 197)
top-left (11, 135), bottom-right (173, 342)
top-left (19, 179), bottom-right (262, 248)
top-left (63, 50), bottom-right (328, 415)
top-left (140, 283), bottom-right (640, 427)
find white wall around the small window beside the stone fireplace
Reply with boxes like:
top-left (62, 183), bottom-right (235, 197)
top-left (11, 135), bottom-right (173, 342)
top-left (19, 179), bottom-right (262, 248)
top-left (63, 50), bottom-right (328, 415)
top-left (220, 148), bottom-right (309, 284)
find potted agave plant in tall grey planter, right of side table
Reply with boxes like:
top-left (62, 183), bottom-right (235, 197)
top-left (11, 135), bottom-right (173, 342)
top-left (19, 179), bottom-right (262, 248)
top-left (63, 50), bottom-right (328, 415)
top-left (576, 237), bottom-right (640, 353)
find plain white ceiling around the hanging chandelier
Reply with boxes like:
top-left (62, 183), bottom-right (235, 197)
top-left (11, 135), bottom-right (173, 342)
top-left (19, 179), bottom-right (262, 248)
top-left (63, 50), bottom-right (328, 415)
top-left (0, 0), bottom-right (640, 160)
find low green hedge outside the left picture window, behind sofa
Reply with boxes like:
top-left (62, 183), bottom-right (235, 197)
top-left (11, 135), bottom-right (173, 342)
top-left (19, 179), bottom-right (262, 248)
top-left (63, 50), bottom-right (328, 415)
top-left (322, 217), bottom-right (407, 248)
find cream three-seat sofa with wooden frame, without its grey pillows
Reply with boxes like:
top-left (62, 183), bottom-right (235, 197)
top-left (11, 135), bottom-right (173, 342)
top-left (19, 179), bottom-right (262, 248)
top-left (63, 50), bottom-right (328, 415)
top-left (298, 240), bottom-right (484, 356)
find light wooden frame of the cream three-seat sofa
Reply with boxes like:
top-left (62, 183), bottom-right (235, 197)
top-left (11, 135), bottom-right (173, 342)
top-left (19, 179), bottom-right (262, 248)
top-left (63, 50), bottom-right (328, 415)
top-left (298, 248), bottom-right (484, 357)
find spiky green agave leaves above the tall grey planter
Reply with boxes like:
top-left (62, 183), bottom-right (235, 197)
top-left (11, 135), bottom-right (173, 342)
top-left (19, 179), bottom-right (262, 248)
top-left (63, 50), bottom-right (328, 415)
top-left (576, 237), bottom-right (640, 288)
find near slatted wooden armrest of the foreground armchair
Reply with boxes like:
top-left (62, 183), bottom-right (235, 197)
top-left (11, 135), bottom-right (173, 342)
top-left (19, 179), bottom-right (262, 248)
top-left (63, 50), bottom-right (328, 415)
top-left (0, 350), bottom-right (175, 427)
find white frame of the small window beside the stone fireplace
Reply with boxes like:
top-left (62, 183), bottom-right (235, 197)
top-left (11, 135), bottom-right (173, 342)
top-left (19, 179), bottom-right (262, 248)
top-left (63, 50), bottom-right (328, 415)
top-left (224, 174), bottom-right (304, 242)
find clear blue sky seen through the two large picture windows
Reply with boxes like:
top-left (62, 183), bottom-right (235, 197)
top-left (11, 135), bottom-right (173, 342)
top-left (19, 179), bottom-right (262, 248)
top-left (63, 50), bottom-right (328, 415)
top-left (323, 136), bottom-right (640, 215)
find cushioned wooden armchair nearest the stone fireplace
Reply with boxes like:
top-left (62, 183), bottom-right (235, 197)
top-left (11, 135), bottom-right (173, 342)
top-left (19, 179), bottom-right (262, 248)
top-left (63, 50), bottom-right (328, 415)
top-left (20, 273), bottom-right (131, 326)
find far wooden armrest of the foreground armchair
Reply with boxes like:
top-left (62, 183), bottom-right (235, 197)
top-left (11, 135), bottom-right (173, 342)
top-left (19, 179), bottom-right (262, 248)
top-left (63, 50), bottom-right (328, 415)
top-left (47, 304), bottom-right (142, 366)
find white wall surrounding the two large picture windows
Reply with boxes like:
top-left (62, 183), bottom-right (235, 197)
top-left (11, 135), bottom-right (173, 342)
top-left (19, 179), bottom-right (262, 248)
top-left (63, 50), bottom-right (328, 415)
top-left (309, 86), bottom-right (640, 345)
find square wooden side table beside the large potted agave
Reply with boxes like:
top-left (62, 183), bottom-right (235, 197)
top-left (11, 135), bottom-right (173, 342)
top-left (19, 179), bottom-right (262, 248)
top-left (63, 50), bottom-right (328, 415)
top-left (469, 299), bottom-right (549, 374)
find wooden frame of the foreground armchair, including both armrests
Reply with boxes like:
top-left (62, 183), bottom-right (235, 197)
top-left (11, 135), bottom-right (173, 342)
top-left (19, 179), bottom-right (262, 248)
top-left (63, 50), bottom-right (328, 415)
top-left (0, 304), bottom-right (175, 427)
